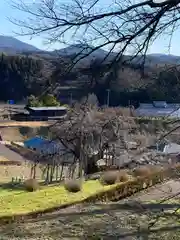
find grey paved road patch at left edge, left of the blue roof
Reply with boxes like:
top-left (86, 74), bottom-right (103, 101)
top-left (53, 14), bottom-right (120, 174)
top-left (0, 144), bottom-right (25, 162)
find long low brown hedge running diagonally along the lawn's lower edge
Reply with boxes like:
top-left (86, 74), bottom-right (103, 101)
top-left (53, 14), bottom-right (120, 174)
top-left (0, 164), bottom-right (180, 224)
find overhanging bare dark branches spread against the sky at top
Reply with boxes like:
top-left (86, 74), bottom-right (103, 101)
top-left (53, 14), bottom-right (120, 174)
top-left (11, 0), bottom-right (180, 66)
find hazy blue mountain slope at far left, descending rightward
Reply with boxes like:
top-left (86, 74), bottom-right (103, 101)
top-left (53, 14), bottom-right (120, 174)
top-left (0, 35), bottom-right (40, 53)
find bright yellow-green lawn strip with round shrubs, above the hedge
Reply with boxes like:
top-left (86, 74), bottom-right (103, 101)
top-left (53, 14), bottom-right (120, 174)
top-left (0, 180), bottom-right (114, 217)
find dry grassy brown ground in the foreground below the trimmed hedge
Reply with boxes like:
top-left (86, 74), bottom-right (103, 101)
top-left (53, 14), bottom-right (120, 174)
top-left (0, 180), bottom-right (180, 240)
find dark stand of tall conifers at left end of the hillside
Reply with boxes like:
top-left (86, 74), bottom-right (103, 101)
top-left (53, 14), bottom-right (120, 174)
top-left (0, 54), bottom-right (51, 101)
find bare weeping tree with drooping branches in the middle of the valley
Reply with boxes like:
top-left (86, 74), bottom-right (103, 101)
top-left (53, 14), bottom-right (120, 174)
top-left (47, 103), bottom-right (135, 176)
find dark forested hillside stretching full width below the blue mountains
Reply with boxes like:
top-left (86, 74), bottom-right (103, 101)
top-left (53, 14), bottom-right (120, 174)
top-left (0, 54), bottom-right (180, 106)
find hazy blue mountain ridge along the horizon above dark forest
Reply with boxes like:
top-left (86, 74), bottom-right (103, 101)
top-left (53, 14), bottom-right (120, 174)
top-left (0, 35), bottom-right (180, 64)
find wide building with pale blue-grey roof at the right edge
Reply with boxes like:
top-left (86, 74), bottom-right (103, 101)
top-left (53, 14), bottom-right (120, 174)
top-left (135, 101), bottom-right (180, 118)
